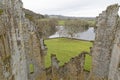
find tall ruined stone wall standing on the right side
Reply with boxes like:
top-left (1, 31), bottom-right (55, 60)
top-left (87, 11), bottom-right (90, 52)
top-left (90, 4), bottom-right (120, 80)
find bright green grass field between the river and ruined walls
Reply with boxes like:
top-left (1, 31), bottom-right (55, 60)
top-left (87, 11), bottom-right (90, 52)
top-left (45, 38), bottom-right (92, 70)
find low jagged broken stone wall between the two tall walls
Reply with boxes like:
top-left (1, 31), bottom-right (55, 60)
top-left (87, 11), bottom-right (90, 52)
top-left (46, 52), bottom-right (89, 80)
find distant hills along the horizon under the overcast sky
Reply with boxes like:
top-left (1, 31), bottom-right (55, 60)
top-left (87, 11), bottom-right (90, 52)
top-left (23, 8), bottom-right (95, 20)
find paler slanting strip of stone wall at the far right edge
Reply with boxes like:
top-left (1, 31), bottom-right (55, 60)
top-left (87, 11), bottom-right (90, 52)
top-left (108, 11), bottom-right (120, 80)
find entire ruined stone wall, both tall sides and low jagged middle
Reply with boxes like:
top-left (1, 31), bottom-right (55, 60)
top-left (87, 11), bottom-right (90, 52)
top-left (0, 0), bottom-right (120, 80)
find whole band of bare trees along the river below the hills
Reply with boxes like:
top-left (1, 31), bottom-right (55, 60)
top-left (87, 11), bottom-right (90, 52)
top-left (37, 18), bottom-right (94, 38)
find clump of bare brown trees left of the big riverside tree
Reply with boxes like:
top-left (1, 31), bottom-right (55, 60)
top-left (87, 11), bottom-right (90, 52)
top-left (37, 19), bottom-right (57, 38)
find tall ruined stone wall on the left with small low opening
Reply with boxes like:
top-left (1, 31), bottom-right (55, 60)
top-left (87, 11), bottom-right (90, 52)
top-left (0, 0), bottom-right (46, 80)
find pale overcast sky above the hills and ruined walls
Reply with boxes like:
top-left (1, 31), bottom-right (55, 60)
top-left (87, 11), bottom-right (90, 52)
top-left (22, 0), bottom-right (120, 17)
